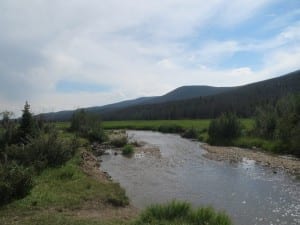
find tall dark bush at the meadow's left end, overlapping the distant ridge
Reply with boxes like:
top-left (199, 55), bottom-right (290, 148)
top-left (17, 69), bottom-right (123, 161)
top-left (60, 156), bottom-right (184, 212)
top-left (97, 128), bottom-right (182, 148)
top-left (70, 109), bottom-right (107, 142)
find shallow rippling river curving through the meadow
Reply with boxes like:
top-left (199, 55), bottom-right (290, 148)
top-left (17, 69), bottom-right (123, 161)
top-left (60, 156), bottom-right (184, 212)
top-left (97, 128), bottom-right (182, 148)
top-left (101, 131), bottom-right (300, 225)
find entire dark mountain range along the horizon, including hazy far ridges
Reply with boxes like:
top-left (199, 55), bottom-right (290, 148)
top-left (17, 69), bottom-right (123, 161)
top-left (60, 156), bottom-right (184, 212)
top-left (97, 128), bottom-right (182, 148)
top-left (42, 70), bottom-right (300, 121)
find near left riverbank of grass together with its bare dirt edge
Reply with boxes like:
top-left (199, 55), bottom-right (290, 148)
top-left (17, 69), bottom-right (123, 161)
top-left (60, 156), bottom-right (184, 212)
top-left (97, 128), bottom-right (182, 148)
top-left (0, 148), bottom-right (138, 225)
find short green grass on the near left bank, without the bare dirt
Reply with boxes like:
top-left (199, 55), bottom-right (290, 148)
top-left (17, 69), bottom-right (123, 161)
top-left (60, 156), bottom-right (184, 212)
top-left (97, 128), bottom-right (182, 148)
top-left (0, 149), bottom-right (128, 224)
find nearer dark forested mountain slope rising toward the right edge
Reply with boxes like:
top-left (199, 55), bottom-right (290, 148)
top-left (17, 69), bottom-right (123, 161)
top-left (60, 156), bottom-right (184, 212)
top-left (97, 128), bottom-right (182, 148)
top-left (102, 70), bottom-right (300, 120)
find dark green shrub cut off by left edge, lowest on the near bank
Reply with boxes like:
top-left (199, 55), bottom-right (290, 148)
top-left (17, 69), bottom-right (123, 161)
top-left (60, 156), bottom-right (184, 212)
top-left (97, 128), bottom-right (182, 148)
top-left (0, 162), bottom-right (33, 205)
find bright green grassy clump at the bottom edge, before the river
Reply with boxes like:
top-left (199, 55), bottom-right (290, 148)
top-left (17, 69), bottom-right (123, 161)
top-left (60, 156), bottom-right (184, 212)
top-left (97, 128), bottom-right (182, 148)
top-left (134, 201), bottom-right (232, 225)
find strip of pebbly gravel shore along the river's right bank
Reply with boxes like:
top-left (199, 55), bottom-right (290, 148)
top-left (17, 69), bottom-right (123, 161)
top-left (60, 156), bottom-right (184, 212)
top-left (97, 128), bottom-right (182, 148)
top-left (201, 144), bottom-right (300, 175)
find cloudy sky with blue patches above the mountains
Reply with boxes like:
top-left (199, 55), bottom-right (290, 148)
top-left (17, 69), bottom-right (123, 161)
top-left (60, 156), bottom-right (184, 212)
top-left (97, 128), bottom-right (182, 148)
top-left (0, 0), bottom-right (300, 115)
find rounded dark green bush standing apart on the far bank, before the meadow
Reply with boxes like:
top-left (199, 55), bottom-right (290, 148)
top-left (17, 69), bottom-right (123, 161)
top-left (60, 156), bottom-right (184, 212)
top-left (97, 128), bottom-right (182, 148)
top-left (208, 113), bottom-right (241, 145)
